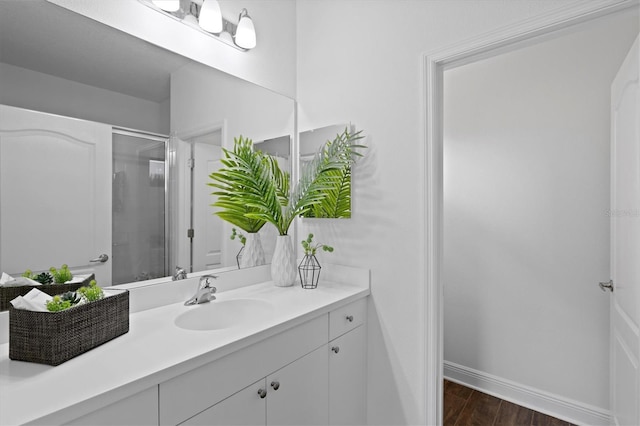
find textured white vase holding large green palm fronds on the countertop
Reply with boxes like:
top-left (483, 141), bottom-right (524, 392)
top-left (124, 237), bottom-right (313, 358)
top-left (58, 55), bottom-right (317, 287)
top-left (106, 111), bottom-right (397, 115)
top-left (209, 129), bottom-right (363, 287)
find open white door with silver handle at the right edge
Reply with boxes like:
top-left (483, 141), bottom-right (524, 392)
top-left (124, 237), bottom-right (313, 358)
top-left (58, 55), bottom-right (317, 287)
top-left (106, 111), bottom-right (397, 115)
top-left (610, 39), bottom-right (640, 425)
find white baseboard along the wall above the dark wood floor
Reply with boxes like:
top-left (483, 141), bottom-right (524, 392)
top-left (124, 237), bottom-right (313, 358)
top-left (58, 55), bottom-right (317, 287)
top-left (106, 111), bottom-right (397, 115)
top-left (444, 361), bottom-right (610, 426)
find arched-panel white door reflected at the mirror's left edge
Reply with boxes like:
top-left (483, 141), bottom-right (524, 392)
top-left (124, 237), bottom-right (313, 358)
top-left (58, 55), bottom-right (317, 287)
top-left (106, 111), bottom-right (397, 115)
top-left (0, 105), bottom-right (111, 285)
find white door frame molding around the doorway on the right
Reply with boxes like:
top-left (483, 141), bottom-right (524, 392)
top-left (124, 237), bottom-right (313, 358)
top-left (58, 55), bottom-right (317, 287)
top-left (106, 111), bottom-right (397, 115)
top-left (420, 0), bottom-right (640, 425)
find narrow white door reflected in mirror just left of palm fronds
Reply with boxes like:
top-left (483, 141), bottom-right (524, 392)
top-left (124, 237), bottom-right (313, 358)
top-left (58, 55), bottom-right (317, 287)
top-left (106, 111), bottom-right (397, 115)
top-left (193, 138), bottom-right (222, 271)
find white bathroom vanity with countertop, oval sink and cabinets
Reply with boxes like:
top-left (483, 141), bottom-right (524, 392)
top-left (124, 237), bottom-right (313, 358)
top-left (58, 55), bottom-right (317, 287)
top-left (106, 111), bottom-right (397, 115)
top-left (0, 265), bottom-right (369, 425)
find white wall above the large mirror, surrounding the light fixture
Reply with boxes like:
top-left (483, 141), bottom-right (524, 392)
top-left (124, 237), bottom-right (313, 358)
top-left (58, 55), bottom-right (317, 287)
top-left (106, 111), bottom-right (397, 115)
top-left (48, 0), bottom-right (296, 98)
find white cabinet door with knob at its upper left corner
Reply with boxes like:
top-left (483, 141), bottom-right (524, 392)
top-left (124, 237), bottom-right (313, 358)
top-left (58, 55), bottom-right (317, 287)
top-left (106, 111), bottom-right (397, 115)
top-left (266, 346), bottom-right (329, 426)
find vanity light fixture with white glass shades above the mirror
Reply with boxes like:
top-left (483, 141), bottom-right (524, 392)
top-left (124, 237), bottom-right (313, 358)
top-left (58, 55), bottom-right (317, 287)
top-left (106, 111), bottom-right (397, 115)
top-left (138, 0), bottom-right (256, 51)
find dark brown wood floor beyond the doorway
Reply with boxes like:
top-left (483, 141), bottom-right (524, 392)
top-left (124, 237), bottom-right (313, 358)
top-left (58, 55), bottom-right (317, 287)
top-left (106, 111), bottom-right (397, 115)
top-left (443, 380), bottom-right (573, 426)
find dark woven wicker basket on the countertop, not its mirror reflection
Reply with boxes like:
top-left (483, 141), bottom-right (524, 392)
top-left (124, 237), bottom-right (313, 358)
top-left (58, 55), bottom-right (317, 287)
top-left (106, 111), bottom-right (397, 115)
top-left (9, 289), bottom-right (129, 365)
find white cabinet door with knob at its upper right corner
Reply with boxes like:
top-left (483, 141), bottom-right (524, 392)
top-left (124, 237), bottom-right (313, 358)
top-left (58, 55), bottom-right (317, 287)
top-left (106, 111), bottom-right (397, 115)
top-left (181, 379), bottom-right (268, 426)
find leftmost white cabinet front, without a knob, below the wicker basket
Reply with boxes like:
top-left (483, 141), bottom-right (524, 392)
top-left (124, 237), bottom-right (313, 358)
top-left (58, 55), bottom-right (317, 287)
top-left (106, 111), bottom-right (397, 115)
top-left (67, 386), bottom-right (158, 426)
